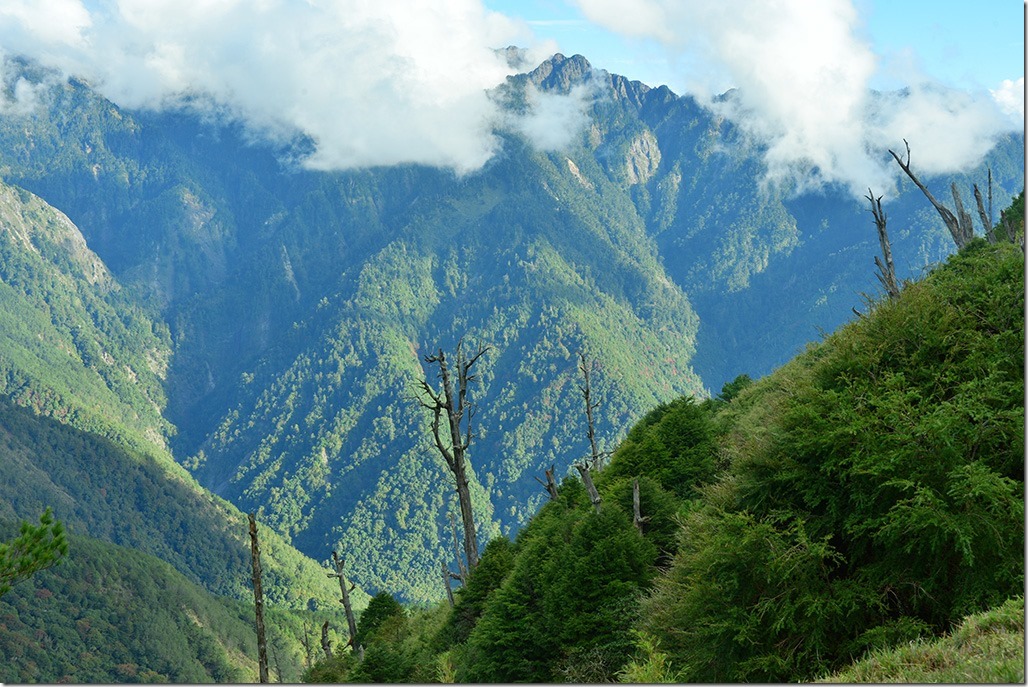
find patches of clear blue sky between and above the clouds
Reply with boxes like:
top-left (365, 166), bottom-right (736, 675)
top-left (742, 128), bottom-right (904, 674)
top-left (484, 0), bottom-right (1024, 93)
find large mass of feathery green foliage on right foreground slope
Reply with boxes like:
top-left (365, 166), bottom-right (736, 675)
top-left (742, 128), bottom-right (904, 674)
top-left (643, 241), bottom-right (1024, 682)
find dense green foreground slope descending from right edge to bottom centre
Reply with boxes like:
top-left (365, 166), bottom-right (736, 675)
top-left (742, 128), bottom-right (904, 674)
top-left (305, 237), bottom-right (1025, 683)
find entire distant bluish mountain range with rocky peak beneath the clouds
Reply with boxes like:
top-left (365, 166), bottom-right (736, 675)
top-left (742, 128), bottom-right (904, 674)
top-left (0, 56), bottom-right (1024, 600)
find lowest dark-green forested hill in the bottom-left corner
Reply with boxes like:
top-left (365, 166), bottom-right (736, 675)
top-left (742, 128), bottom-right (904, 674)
top-left (0, 520), bottom-right (347, 684)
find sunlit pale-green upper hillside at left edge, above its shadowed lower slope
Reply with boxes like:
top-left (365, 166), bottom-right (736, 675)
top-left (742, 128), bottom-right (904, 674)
top-left (0, 183), bottom-right (172, 455)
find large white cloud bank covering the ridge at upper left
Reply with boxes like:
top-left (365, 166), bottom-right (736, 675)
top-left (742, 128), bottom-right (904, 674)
top-left (0, 0), bottom-right (577, 173)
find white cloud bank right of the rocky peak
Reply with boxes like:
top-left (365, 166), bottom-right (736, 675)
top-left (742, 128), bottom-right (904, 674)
top-left (577, 0), bottom-right (1024, 196)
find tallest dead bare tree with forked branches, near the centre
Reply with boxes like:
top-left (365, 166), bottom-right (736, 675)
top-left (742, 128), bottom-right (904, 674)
top-left (417, 339), bottom-right (490, 572)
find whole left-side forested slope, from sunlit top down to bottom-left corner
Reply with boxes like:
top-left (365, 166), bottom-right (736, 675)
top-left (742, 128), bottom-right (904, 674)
top-left (0, 176), bottom-right (353, 682)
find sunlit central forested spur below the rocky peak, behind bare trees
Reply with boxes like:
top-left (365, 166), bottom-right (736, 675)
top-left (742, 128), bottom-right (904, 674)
top-left (196, 133), bottom-right (700, 599)
